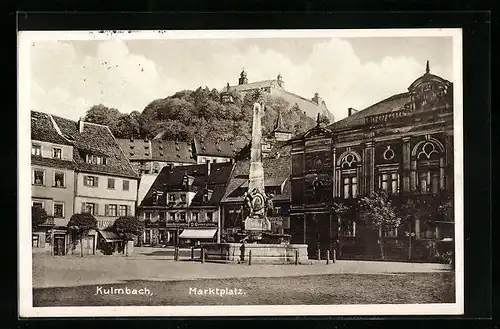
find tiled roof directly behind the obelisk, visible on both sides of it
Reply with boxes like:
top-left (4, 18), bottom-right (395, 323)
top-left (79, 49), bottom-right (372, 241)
top-left (221, 156), bottom-right (291, 202)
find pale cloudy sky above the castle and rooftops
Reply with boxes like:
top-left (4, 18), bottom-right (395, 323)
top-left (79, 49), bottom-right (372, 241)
top-left (29, 33), bottom-right (453, 120)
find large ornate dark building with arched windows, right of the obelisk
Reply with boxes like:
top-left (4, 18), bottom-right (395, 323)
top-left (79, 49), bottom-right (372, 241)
top-left (290, 63), bottom-right (454, 260)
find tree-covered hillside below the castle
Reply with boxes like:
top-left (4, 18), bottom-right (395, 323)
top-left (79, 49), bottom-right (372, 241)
top-left (84, 87), bottom-right (328, 141)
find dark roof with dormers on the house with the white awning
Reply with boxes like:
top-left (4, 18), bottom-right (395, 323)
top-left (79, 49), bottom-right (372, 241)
top-left (141, 162), bottom-right (233, 207)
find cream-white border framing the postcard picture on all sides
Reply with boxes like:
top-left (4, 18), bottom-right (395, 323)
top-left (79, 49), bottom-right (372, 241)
top-left (18, 28), bottom-right (464, 317)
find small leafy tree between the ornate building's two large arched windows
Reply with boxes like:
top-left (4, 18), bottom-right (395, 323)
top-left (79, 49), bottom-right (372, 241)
top-left (359, 191), bottom-right (401, 259)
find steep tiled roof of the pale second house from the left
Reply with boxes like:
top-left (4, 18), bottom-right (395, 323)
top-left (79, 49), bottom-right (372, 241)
top-left (43, 110), bottom-right (138, 178)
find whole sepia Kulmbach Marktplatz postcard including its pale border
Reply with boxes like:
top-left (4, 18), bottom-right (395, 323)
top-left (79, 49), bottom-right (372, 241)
top-left (18, 29), bottom-right (464, 317)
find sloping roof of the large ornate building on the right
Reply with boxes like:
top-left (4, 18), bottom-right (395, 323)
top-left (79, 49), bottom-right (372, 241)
top-left (327, 92), bottom-right (410, 130)
